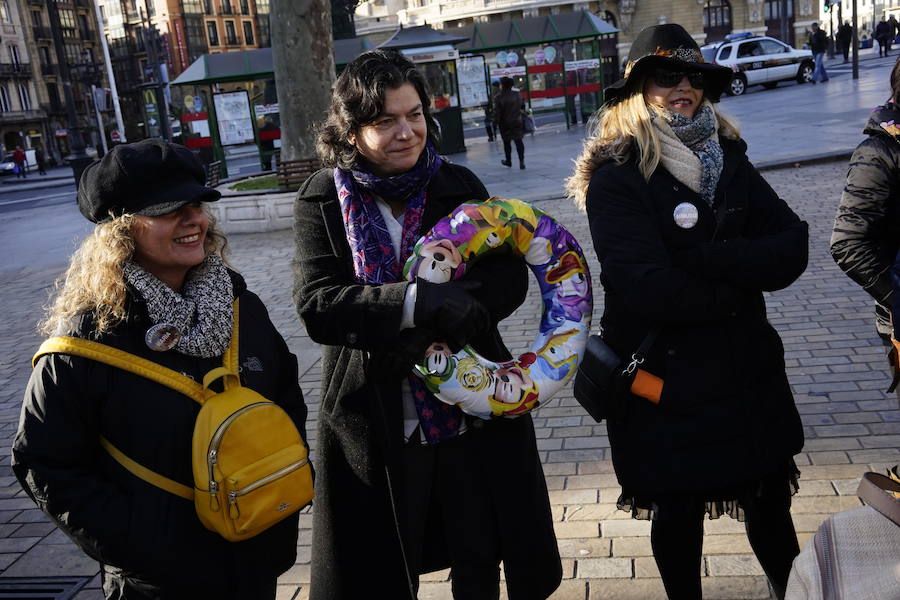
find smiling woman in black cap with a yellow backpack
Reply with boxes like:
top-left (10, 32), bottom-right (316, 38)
top-left (12, 139), bottom-right (307, 600)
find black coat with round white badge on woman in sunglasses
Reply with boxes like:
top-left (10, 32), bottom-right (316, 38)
top-left (587, 139), bottom-right (808, 496)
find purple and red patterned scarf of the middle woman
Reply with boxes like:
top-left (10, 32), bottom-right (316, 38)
top-left (334, 142), bottom-right (462, 444)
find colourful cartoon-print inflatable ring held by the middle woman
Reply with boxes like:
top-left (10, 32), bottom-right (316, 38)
top-left (403, 198), bottom-right (593, 419)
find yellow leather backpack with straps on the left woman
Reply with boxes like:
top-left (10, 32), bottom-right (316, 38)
top-left (32, 300), bottom-right (314, 542)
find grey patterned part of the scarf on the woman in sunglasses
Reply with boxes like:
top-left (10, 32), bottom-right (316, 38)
top-left (663, 103), bottom-right (725, 206)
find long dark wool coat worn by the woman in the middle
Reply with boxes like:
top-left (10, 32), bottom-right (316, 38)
top-left (294, 163), bottom-right (561, 600)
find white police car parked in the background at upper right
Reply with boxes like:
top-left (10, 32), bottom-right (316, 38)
top-left (700, 32), bottom-right (815, 96)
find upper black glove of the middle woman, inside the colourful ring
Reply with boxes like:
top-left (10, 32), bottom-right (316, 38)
top-left (413, 279), bottom-right (491, 352)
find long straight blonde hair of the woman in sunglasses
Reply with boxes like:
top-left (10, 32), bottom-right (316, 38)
top-left (566, 81), bottom-right (741, 210)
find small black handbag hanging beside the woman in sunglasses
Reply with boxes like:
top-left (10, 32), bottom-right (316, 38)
top-left (574, 327), bottom-right (659, 423)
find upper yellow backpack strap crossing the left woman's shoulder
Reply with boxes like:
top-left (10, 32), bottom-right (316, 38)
top-left (31, 336), bottom-right (207, 404)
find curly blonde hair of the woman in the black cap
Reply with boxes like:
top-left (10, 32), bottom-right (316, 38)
top-left (38, 205), bottom-right (228, 335)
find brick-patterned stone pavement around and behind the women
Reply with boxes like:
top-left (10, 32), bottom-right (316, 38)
top-left (0, 156), bottom-right (900, 600)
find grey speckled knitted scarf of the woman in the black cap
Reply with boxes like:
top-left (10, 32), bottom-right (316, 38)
top-left (124, 254), bottom-right (234, 358)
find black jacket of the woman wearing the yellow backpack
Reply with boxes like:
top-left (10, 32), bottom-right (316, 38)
top-left (12, 273), bottom-right (307, 597)
